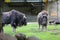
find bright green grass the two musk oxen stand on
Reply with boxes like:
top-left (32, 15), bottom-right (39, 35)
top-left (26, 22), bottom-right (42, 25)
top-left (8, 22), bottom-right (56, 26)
top-left (4, 23), bottom-right (60, 40)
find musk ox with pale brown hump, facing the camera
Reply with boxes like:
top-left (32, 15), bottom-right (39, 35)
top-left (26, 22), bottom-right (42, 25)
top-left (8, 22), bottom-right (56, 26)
top-left (37, 10), bottom-right (48, 29)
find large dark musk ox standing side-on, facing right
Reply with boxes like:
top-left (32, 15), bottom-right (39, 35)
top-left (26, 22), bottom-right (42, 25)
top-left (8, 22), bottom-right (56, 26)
top-left (1, 10), bottom-right (27, 31)
